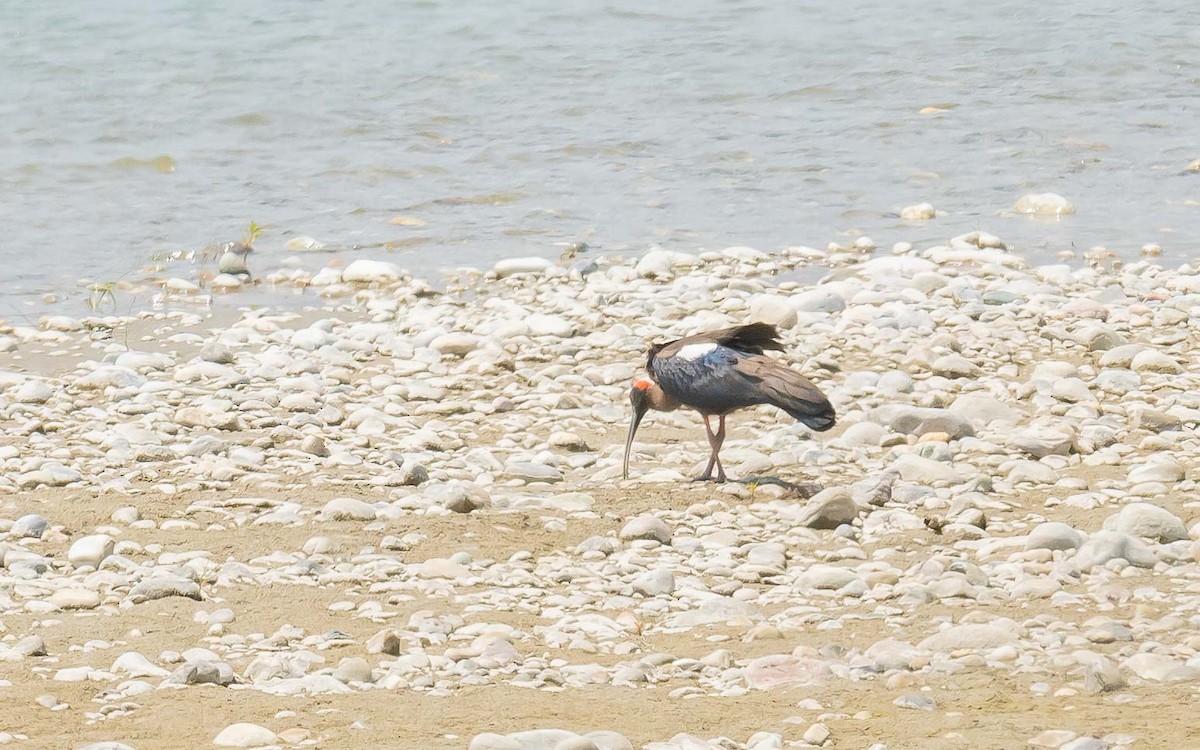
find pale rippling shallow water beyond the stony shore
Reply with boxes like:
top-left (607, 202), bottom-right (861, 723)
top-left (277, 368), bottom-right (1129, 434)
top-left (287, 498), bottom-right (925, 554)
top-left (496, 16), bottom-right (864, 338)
top-left (0, 0), bottom-right (1200, 317)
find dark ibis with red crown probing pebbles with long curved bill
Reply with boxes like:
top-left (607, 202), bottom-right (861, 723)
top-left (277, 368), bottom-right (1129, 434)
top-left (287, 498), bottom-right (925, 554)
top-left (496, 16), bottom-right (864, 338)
top-left (623, 323), bottom-right (836, 482)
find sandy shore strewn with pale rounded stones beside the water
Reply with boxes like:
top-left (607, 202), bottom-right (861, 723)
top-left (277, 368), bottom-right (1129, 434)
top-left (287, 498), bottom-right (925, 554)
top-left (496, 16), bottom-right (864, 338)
top-left (0, 233), bottom-right (1200, 750)
